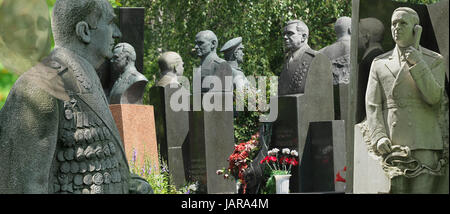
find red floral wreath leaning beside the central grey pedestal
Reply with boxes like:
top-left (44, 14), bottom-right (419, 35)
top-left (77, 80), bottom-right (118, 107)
top-left (216, 132), bottom-right (259, 194)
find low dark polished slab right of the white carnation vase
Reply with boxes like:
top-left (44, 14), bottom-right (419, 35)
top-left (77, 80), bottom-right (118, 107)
top-left (299, 120), bottom-right (347, 192)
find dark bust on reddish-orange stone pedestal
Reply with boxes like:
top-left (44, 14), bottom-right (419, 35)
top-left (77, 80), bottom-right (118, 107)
top-left (109, 43), bottom-right (159, 173)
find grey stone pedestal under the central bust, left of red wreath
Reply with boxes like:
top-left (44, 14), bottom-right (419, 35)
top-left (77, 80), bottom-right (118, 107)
top-left (189, 92), bottom-right (236, 194)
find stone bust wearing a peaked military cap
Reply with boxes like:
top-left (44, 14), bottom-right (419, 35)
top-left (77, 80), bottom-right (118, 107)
top-left (220, 37), bottom-right (248, 90)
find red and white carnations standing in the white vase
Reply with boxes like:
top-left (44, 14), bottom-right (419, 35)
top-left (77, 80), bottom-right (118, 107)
top-left (259, 148), bottom-right (298, 175)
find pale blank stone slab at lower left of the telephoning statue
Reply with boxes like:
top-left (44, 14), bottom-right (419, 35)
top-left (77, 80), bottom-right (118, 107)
top-left (353, 124), bottom-right (391, 194)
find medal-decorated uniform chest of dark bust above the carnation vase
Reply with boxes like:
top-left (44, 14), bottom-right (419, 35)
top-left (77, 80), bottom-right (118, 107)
top-left (278, 45), bottom-right (329, 95)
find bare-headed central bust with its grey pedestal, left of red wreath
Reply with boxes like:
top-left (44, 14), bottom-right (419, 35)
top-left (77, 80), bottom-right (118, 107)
top-left (188, 30), bottom-right (236, 193)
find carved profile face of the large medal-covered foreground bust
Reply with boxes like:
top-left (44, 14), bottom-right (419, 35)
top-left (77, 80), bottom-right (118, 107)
top-left (90, 1), bottom-right (120, 59)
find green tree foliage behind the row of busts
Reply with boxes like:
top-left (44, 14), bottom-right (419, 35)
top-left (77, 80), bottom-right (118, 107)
top-left (121, 0), bottom-right (351, 86)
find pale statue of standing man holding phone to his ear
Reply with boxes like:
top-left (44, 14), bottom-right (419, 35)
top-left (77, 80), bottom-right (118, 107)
top-left (355, 7), bottom-right (448, 194)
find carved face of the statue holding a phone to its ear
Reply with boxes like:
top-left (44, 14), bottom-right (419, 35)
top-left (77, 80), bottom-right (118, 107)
top-left (391, 11), bottom-right (414, 47)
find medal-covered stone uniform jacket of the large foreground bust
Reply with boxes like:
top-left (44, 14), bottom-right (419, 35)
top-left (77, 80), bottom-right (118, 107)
top-left (0, 48), bottom-right (131, 194)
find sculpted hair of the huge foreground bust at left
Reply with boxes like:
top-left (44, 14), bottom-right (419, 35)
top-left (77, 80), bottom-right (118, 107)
top-left (52, 0), bottom-right (109, 45)
